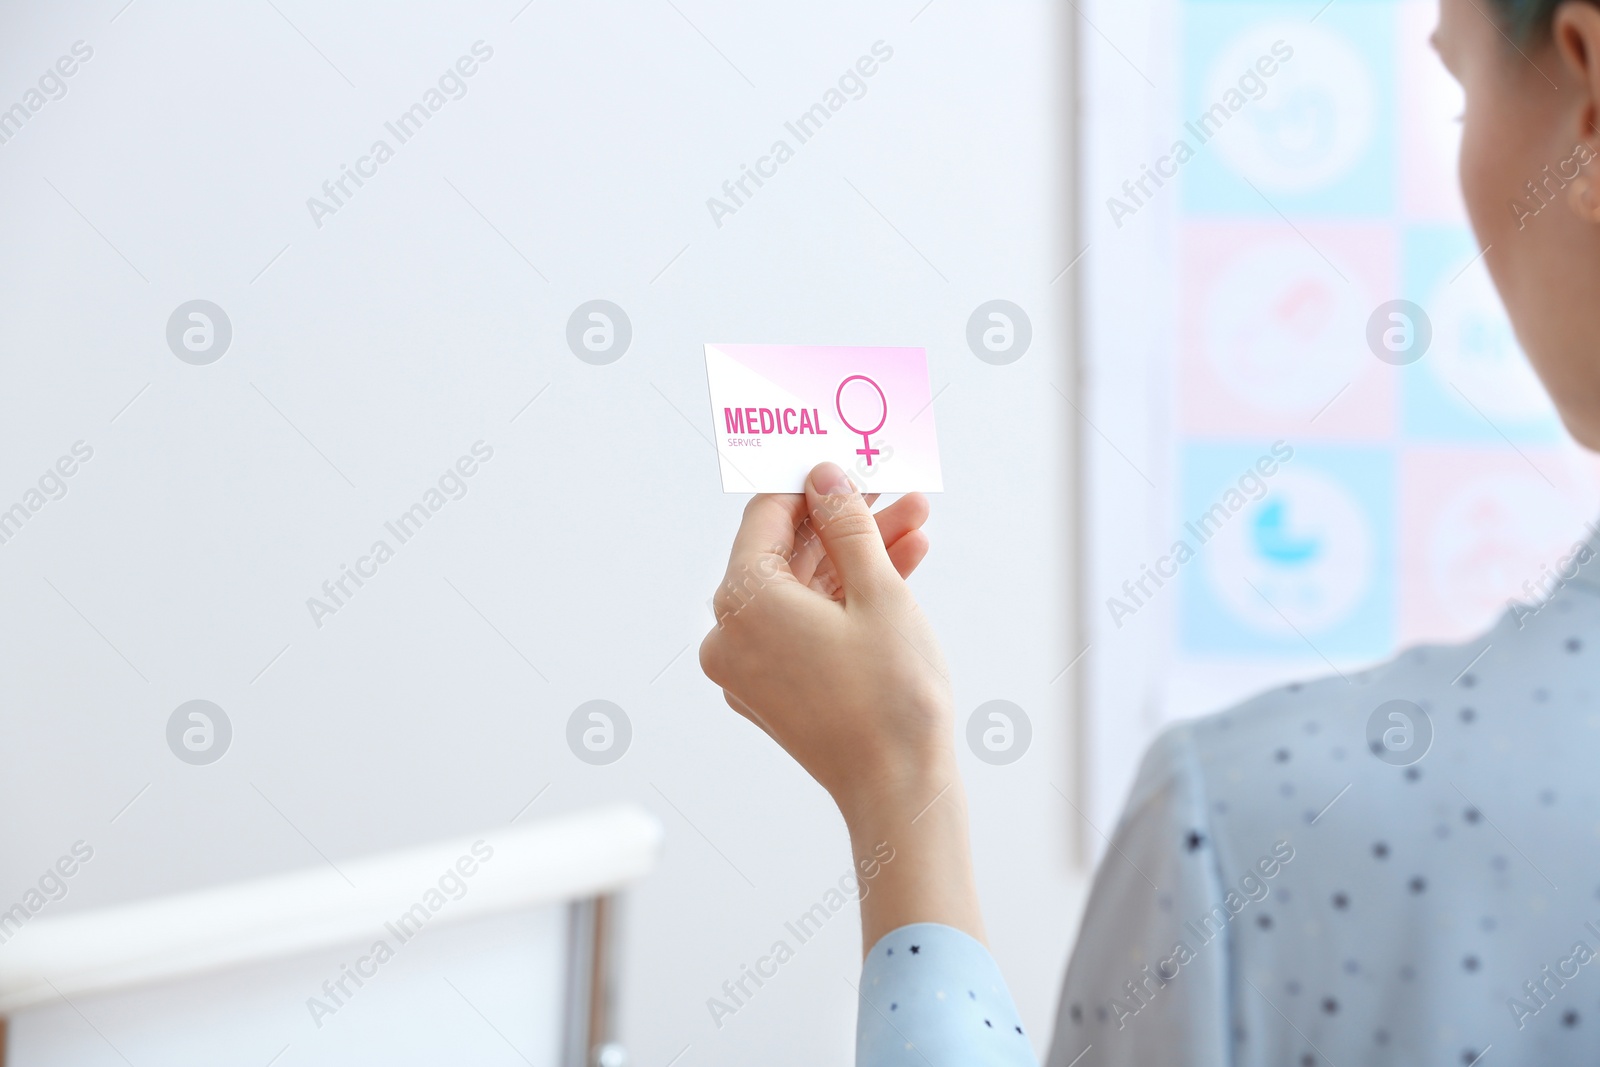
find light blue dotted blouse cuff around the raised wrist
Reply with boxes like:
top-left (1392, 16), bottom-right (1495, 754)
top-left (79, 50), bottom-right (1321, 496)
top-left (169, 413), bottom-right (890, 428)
top-left (856, 923), bottom-right (1037, 1067)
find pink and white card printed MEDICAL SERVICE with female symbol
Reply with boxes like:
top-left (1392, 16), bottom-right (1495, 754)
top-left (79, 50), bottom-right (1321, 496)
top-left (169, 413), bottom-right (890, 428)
top-left (706, 344), bottom-right (944, 493)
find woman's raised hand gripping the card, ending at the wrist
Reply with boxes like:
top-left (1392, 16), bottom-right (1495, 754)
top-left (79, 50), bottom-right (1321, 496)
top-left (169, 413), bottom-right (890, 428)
top-left (701, 464), bottom-right (950, 817)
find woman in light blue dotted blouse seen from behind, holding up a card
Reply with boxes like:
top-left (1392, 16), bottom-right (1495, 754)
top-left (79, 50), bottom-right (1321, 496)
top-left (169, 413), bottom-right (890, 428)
top-left (701, 0), bottom-right (1600, 1067)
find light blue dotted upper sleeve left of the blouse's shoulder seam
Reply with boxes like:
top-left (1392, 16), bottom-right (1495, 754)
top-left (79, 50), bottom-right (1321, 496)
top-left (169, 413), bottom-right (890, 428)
top-left (1050, 726), bottom-right (1234, 1067)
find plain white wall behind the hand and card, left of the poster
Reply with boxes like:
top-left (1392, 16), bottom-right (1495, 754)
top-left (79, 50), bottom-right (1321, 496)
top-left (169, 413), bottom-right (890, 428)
top-left (0, 0), bottom-right (1082, 1067)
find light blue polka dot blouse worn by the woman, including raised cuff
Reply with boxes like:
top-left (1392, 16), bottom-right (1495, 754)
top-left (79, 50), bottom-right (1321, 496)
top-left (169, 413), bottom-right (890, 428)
top-left (858, 563), bottom-right (1600, 1067)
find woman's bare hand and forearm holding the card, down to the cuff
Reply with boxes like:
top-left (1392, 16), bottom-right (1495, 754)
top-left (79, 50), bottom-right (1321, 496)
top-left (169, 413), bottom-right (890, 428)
top-left (701, 464), bottom-right (982, 947)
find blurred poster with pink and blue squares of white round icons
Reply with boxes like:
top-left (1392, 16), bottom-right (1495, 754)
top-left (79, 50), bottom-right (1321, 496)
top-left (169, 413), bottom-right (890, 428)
top-left (1083, 0), bottom-right (1600, 829)
